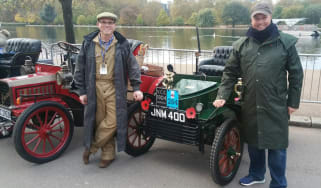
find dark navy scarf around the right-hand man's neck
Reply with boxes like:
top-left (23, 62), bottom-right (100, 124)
top-left (246, 22), bottom-right (280, 43)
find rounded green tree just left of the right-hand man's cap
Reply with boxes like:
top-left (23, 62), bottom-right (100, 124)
top-left (222, 2), bottom-right (250, 27)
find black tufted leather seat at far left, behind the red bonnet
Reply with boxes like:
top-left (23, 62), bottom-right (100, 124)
top-left (0, 38), bottom-right (41, 78)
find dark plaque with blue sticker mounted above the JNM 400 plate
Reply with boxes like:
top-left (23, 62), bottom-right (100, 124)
top-left (156, 88), bottom-right (179, 109)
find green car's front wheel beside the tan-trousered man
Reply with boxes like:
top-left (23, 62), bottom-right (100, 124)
top-left (125, 103), bottom-right (155, 157)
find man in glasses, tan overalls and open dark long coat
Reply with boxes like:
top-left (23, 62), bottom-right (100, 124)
top-left (74, 12), bottom-right (143, 168)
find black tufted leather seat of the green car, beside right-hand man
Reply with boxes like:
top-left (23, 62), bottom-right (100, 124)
top-left (199, 46), bottom-right (233, 76)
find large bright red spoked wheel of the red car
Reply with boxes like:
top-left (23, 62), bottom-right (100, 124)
top-left (13, 101), bottom-right (74, 163)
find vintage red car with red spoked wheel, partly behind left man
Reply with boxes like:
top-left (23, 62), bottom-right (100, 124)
top-left (0, 40), bottom-right (162, 163)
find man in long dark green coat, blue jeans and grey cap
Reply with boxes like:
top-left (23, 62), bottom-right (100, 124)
top-left (213, 2), bottom-right (303, 188)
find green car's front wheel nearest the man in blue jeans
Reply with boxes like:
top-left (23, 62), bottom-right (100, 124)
top-left (210, 119), bottom-right (243, 185)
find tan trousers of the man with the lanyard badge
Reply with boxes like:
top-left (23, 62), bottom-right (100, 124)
top-left (90, 80), bottom-right (117, 160)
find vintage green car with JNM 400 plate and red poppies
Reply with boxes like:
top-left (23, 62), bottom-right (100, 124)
top-left (126, 63), bottom-right (243, 185)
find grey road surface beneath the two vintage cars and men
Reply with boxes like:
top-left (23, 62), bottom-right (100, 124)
top-left (0, 126), bottom-right (321, 188)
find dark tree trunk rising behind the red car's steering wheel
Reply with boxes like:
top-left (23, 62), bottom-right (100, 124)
top-left (59, 0), bottom-right (76, 44)
